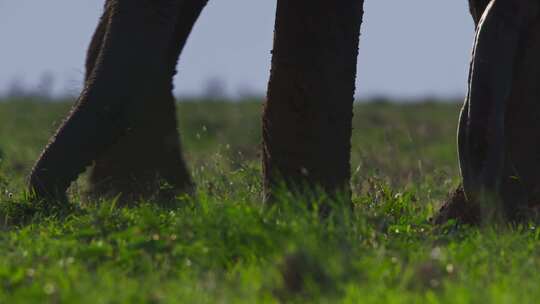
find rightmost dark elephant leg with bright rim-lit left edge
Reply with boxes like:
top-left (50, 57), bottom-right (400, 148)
top-left (458, 0), bottom-right (540, 219)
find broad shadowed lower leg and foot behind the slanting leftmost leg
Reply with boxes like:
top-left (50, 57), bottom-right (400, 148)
top-left (85, 119), bottom-right (194, 205)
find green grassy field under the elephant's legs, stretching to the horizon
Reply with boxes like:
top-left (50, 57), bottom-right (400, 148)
top-left (0, 100), bottom-right (540, 303)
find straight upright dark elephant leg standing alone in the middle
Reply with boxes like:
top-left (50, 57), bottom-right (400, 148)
top-left (263, 0), bottom-right (363, 211)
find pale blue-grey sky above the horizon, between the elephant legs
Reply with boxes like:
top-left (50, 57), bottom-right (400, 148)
top-left (0, 0), bottom-right (473, 98)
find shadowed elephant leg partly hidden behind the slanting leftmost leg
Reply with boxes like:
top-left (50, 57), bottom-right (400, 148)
top-left (87, 0), bottom-right (206, 201)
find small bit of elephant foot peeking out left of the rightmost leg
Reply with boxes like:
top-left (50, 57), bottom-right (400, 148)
top-left (431, 186), bottom-right (481, 225)
